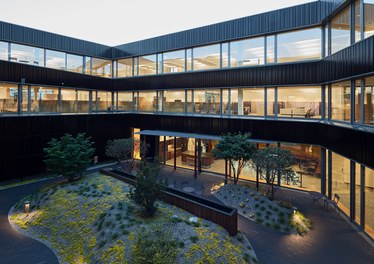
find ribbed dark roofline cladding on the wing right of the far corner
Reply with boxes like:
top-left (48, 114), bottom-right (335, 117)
top-left (113, 0), bottom-right (344, 57)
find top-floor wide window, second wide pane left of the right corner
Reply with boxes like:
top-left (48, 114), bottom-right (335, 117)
top-left (230, 37), bottom-right (264, 67)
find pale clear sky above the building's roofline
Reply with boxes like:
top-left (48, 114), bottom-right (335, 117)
top-left (0, 0), bottom-right (312, 45)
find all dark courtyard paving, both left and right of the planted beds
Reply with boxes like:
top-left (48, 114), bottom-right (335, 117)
top-left (0, 164), bottom-right (374, 264)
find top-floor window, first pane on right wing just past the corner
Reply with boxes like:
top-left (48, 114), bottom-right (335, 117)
top-left (331, 7), bottom-right (351, 53)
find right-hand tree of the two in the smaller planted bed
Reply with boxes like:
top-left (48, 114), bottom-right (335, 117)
top-left (252, 147), bottom-right (299, 200)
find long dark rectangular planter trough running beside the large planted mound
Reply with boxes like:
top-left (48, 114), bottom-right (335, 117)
top-left (100, 169), bottom-right (238, 236)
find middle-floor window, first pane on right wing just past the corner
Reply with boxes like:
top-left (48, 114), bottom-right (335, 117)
top-left (331, 81), bottom-right (351, 121)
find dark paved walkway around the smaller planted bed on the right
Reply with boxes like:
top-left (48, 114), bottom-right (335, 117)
top-left (164, 167), bottom-right (374, 264)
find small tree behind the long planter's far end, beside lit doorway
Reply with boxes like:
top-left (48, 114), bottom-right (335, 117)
top-left (105, 138), bottom-right (148, 173)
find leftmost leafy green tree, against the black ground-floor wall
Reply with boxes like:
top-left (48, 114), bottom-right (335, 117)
top-left (43, 133), bottom-right (95, 182)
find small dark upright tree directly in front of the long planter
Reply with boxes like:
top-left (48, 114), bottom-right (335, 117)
top-left (129, 161), bottom-right (166, 217)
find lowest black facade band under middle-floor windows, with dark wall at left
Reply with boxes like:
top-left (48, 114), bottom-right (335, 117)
top-left (0, 114), bottom-right (374, 179)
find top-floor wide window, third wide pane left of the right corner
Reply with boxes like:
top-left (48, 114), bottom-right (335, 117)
top-left (193, 44), bottom-right (220, 71)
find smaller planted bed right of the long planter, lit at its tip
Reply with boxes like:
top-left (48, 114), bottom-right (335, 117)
top-left (213, 184), bottom-right (312, 235)
